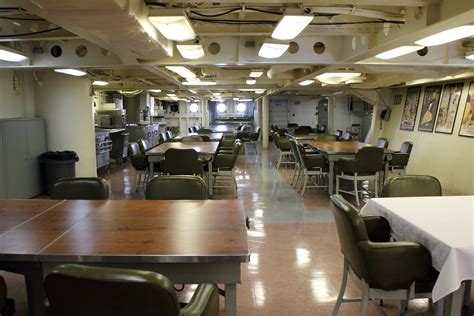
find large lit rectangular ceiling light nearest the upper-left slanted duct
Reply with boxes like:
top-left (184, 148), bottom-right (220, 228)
top-left (148, 9), bottom-right (196, 42)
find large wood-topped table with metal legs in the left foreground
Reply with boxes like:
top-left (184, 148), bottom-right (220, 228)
top-left (0, 200), bottom-right (249, 316)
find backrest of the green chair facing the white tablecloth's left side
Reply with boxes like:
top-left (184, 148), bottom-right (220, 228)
top-left (330, 195), bottom-right (369, 278)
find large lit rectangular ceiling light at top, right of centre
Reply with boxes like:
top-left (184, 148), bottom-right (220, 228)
top-left (272, 9), bottom-right (314, 40)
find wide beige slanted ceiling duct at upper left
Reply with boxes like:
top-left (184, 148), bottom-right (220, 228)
top-left (18, 0), bottom-right (173, 64)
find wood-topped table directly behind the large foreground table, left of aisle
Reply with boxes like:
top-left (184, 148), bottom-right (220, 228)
top-left (146, 142), bottom-right (219, 197)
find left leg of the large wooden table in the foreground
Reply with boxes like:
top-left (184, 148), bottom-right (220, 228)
top-left (25, 269), bottom-right (46, 316)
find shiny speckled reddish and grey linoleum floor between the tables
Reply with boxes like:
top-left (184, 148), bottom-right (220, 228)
top-left (1, 147), bottom-right (474, 315)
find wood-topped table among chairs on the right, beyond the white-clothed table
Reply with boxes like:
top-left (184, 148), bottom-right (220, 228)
top-left (304, 141), bottom-right (393, 195)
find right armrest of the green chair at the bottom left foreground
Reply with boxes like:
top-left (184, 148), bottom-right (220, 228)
top-left (181, 283), bottom-right (219, 316)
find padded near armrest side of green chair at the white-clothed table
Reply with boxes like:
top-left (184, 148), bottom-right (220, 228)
top-left (358, 241), bottom-right (433, 291)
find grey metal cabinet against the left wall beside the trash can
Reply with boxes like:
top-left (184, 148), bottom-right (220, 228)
top-left (0, 119), bottom-right (46, 199)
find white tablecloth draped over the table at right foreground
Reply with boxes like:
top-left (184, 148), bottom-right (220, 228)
top-left (361, 196), bottom-right (474, 302)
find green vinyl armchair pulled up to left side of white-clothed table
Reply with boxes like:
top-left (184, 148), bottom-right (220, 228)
top-left (330, 195), bottom-right (438, 316)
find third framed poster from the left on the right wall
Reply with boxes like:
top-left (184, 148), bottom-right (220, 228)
top-left (435, 83), bottom-right (463, 134)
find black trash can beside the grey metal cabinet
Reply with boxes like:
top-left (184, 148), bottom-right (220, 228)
top-left (40, 150), bottom-right (79, 195)
